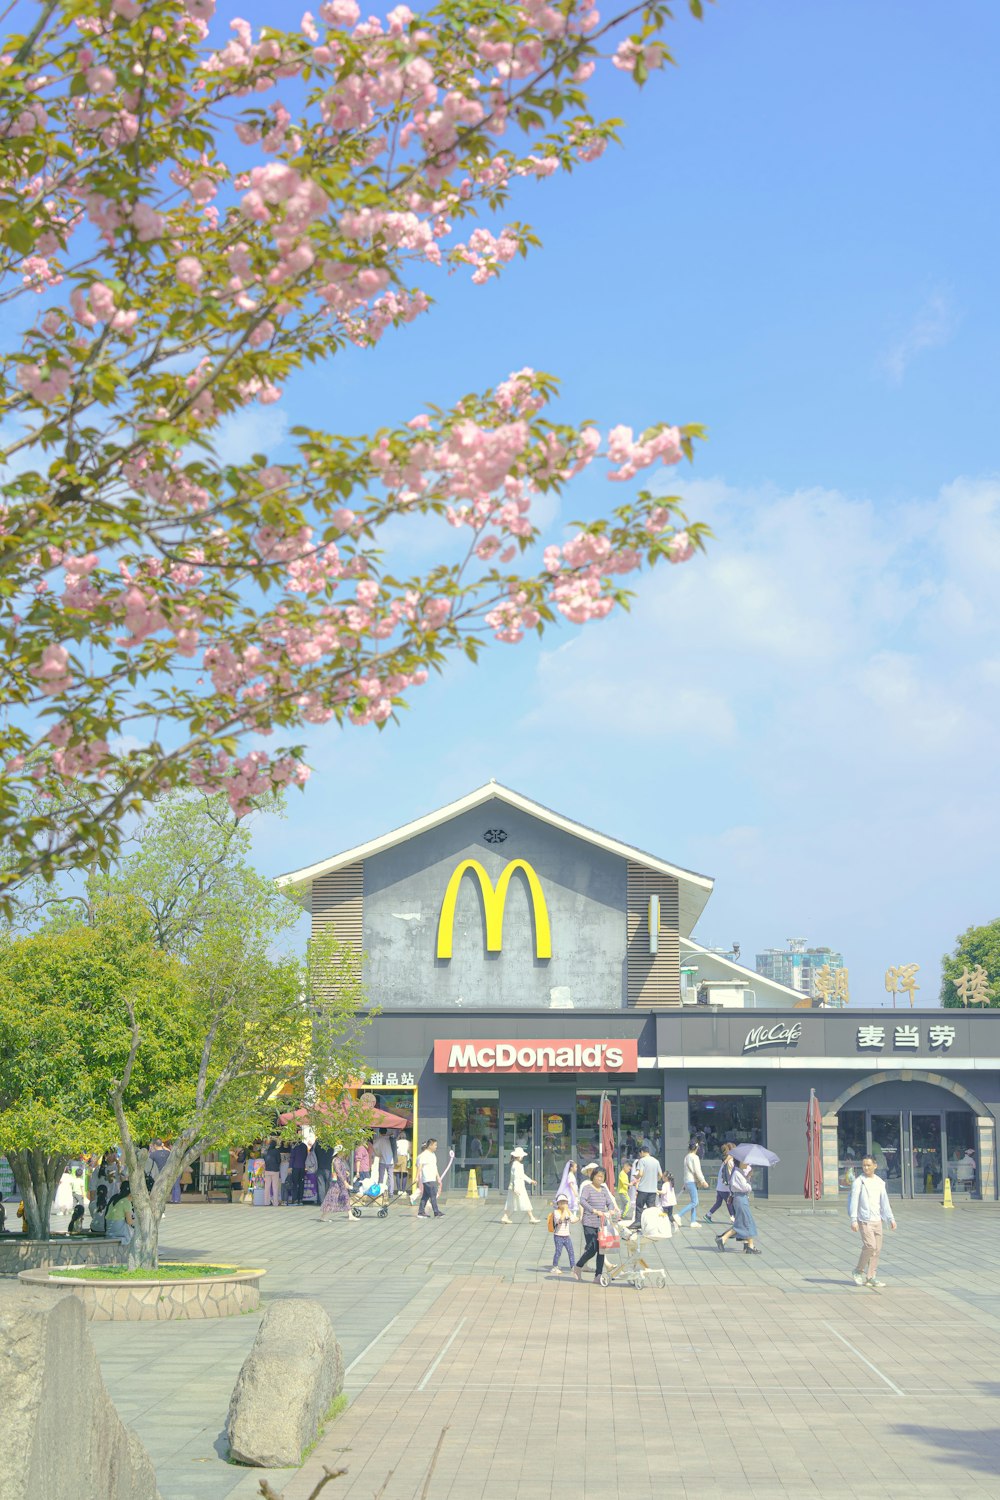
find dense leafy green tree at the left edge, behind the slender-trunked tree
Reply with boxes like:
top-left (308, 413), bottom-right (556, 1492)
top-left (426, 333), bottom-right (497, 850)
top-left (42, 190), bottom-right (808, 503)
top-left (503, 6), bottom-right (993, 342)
top-left (0, 906), bottom-right (183, 1239)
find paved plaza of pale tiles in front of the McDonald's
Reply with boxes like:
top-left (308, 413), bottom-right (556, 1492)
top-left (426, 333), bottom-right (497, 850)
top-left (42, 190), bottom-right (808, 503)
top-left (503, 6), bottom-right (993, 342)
top-left (83, 1199), bottom-right (1000, 1500)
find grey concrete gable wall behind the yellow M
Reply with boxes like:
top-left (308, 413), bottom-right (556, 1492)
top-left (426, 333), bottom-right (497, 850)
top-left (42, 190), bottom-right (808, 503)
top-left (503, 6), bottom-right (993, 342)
top-left (364, 803), bottom-right (627, 1010)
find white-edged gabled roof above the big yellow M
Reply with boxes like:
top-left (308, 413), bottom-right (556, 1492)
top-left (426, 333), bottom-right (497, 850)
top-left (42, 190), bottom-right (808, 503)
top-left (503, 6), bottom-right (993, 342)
top-left (277, 782), bottom-right (715, 933)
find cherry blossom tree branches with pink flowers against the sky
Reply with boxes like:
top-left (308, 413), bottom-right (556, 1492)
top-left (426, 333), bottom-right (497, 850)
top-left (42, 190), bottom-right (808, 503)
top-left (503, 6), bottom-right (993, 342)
top-left (0, 0), bottom-right (705, 900)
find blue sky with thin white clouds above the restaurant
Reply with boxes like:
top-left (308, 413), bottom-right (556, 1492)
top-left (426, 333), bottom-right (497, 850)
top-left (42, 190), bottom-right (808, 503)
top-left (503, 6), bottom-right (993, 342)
top-left (229, 0), bottom-right (1000, 1004)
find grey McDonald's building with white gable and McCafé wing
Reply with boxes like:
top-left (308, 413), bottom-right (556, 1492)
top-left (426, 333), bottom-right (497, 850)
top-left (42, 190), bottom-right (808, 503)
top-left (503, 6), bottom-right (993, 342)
top-left (279, 782), bottom-right (1000, 1199)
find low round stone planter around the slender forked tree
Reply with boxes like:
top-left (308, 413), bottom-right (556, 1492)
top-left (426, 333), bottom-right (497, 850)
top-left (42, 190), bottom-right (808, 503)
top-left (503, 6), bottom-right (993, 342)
top-left (18, 1266), bottom-right (267, 1323)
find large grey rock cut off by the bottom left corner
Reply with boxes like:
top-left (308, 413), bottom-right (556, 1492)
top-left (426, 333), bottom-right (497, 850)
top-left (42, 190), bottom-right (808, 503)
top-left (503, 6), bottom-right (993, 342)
top-left (0, 1284), bottom-right (159, 1500)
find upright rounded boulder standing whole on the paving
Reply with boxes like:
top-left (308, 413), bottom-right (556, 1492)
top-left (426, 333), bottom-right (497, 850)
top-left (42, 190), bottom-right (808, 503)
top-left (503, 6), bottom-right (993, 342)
top-left (226, 1299), bottom-right (343, 1464)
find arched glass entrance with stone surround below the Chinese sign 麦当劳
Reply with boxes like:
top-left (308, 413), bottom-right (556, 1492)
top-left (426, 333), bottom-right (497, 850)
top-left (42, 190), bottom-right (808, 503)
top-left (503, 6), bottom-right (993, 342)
top-left (823, 1071), bottom-right (997, 1199)
